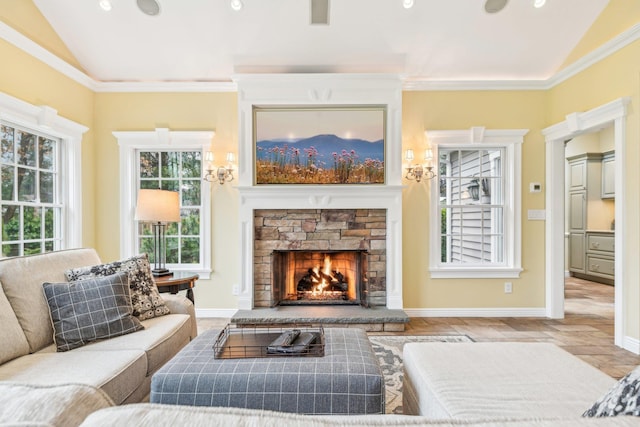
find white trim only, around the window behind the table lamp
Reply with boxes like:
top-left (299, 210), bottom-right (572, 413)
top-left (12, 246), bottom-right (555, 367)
top-left (113, 128), bottom-right (215, 279)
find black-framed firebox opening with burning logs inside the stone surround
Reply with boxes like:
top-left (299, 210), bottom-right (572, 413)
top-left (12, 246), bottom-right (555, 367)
top-left (272, 250), bottom-right (368, 306)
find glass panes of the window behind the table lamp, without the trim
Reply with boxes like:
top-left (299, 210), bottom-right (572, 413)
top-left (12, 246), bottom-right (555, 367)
top-left (137, 150), bottom-right (203, 268)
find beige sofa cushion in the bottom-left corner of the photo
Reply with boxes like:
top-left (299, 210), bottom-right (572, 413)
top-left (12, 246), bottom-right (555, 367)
top-left (0, 382), bottom-right (113, 427)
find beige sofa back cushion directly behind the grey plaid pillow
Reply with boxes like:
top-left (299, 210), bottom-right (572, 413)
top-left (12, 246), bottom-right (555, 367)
top-left (0, 249), bottom-right (100, 352)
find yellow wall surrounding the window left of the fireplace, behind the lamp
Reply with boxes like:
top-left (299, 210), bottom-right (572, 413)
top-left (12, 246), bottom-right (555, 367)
top-left (94, 93), bottom-right (240, 309)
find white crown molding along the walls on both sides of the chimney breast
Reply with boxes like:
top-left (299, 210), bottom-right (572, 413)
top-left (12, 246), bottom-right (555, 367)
top-left (0, 21), bottom-right (640, 93)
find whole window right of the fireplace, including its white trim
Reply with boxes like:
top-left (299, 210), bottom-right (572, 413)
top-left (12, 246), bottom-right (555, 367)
top-left (427, 128), bottom-right (526, 278)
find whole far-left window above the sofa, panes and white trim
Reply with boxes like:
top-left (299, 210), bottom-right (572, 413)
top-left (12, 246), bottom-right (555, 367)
top-left (0, 93), bottom-right (87, 257)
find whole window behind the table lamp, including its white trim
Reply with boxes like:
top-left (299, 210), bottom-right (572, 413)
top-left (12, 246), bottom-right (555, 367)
top-left (113, 129), bottom-right (214, 279)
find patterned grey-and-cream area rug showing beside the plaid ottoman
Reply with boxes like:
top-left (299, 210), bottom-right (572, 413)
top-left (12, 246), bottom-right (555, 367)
top-left (369, 335), bottom-right (473, 414)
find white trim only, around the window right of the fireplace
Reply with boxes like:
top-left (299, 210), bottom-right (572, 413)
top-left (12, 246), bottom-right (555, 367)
top-left (425, 127), bottom-right (529, 279)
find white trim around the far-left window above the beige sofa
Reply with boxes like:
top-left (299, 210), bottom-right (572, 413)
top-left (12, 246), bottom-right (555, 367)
top-left (0, 92), bottom-right (89, 249)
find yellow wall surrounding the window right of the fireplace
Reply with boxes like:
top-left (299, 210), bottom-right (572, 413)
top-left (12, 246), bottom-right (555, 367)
top-left (402, 91), bottom-right (546, 308)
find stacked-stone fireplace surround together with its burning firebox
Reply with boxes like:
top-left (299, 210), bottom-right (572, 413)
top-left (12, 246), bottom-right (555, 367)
top-left (253, 209), bottom-right (387, 307)
